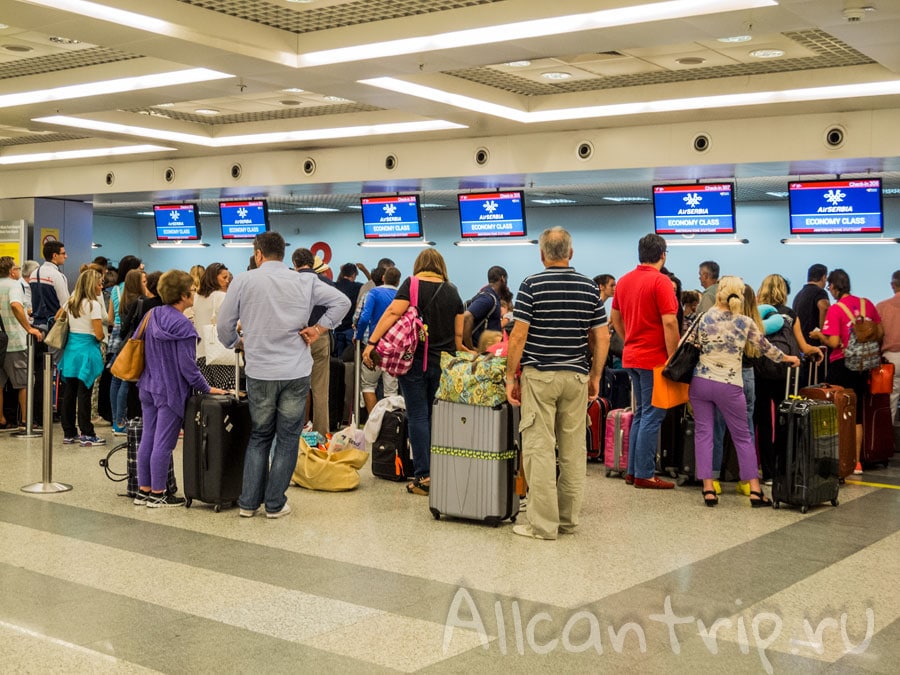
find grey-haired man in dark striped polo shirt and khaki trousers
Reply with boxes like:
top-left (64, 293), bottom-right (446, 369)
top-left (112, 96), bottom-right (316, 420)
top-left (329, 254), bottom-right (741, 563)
top-left (506, 227), bottom-right (609, 539)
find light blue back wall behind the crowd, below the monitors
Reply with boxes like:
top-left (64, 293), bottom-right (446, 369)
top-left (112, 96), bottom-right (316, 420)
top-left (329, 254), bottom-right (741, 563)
top-left (95, 199), bottom-right (900, 301)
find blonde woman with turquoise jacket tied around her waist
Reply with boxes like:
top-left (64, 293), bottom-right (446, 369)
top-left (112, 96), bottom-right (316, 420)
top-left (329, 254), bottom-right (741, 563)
top-left (59, 268), bottom-right (106, 447)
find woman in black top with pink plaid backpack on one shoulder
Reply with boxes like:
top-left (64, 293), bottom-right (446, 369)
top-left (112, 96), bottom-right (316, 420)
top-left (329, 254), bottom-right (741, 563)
top-left (362, 248), bottom-right (466, 495)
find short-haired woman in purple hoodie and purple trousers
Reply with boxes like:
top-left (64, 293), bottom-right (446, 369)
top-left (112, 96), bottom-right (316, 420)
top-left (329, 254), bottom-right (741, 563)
top-left (134, 270), bottom-right (226, 508)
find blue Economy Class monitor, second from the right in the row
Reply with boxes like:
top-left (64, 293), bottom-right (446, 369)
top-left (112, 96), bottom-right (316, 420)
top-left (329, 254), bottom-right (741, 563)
top-left (653, 183), bottom-right (735, 234)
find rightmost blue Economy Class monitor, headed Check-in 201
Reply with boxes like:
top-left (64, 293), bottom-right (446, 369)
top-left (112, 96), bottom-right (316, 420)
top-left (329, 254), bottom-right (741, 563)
top-left (788, 178), bottom-right (884, 234)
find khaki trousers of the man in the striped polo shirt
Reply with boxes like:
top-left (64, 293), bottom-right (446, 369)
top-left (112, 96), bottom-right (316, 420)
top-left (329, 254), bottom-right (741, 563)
top-left (519, 366), bottom-right (588, 539)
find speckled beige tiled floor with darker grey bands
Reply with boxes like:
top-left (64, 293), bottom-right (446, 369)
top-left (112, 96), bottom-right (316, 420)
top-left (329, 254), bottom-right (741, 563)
top-left (0, 427), bottom-right (900, 673)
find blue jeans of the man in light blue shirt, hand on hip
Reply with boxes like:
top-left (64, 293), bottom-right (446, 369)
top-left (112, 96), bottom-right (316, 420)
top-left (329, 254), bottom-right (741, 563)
top-left (238, 376), bottom-right (309, 513)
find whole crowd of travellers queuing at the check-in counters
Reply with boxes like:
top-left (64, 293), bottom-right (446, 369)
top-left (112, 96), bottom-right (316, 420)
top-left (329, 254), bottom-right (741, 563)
top-left (0, 227), bottom-right (900, 528)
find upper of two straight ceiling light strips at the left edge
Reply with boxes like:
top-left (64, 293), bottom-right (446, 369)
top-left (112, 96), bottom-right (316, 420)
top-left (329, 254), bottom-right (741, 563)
top-left (0, 68), bottom-right (233, 108)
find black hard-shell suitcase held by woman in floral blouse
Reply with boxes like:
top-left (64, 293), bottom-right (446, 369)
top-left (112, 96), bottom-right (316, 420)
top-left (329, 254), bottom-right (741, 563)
top-left (772, 368), bottom-right (839, 513)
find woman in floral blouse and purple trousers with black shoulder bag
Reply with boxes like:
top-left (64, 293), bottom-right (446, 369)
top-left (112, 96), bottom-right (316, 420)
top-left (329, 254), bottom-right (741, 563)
top-left (690, 276), bottom-right (800, 508)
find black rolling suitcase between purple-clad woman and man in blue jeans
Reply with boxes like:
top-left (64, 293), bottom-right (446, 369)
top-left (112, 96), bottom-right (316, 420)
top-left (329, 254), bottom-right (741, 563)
top-left (183, 359), bottom-right (250, 512)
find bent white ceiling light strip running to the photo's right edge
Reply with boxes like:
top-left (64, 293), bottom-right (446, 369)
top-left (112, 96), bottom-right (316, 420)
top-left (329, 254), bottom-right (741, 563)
top-left (359, 77), bottom-right (900, 124)
